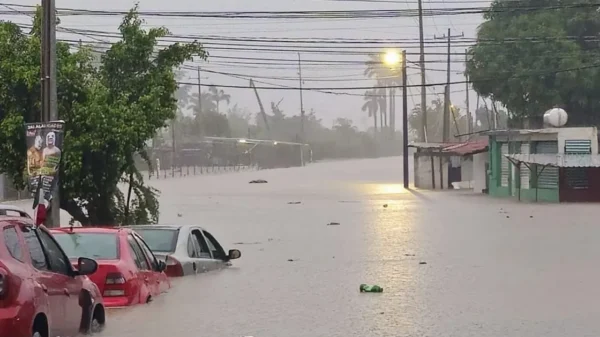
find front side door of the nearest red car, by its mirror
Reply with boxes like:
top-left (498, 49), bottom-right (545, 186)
top-left (36, 228), bottom-right (82, 336)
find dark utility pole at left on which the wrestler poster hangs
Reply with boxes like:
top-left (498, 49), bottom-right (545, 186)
top-left (41, 0), bottom-right (60, 227)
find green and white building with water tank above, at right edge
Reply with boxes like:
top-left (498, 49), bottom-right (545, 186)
top-left (486, 127), bottom-right (600, 202)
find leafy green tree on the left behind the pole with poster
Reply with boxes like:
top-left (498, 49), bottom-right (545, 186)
top-left (0, 7), bottom-right (205, 225)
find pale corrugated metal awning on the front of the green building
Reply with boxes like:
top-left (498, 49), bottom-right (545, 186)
top-left (506, 153), bottom-right (600, 167)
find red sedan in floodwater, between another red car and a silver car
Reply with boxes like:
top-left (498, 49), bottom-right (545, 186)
top-left (52, 227), bottom-right (171, 307)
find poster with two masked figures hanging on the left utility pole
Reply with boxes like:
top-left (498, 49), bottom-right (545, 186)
top-left (25, 121), bottom-right (65, 200)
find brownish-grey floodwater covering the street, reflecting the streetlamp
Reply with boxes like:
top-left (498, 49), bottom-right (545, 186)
top-left (59, 158), bottom-right (600, 337)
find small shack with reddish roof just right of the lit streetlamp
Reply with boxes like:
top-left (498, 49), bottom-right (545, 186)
top-left (408, 138), bottom-right (488, 192)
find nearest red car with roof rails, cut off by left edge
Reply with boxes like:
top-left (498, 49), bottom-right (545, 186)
top-left (0, 210), bottom-right (105, 337)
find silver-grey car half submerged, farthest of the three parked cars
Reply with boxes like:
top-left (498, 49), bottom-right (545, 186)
top-left (130, 225), bottom-right (242, 276)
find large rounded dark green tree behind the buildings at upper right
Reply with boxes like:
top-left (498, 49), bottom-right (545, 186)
top-left (467, 0), bottom-right (600, 124)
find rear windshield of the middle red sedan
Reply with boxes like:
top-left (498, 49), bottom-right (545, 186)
top-left (54, 233), bottom-right (119, 260)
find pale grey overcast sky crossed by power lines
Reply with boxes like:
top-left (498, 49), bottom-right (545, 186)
top-left (3, 0), bottom-right (489, 129)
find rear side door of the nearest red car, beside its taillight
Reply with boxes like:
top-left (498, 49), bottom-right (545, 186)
top-left (20, 225), bottom-right (69, 337)
